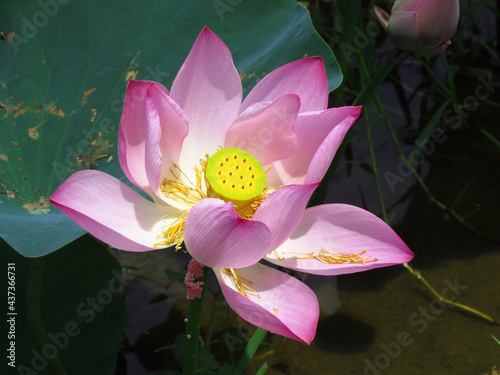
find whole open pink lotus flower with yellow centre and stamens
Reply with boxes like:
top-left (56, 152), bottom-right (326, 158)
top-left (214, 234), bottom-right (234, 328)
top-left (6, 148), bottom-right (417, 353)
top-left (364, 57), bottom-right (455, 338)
top-left (51, 28), bottom-right (413, 343)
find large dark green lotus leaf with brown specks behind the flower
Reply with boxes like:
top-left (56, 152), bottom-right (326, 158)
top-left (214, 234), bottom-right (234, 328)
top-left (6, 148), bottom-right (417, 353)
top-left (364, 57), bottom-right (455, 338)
top-left (0, 0), bottom-right (341, 257)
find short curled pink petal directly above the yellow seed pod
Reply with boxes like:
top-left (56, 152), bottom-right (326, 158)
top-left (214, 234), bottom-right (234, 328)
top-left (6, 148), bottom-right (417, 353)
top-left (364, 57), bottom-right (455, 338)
top-left (224, 94), bottom-right (300, 165)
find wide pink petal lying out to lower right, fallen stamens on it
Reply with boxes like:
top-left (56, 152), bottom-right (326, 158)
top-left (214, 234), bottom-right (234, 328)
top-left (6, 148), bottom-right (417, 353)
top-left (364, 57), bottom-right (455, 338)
top-left (265, 204), bottom-right (413, 275)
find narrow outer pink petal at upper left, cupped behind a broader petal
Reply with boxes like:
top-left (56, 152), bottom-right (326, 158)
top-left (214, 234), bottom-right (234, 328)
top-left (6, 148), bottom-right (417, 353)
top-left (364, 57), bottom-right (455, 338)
top-left (118, 80), bottom-right (168, 197)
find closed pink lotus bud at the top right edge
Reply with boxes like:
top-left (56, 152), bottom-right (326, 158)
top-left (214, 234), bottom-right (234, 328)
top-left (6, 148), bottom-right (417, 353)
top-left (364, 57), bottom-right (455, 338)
top-left (374, 0), bottom-right (460, 57)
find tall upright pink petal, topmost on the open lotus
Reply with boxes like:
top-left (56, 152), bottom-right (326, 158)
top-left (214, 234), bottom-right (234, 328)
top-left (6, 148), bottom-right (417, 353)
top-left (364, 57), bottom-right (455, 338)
top-left (171, 27), bottom-right (242, 170)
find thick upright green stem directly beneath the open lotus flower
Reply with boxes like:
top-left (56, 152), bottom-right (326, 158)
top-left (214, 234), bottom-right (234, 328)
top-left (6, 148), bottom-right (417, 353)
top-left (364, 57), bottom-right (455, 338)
top-left (182, 267), bottom-right (208, 375)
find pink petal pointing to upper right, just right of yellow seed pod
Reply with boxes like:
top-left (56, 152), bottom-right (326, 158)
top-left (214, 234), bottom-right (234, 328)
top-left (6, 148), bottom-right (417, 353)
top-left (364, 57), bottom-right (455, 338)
top-left (269, 107), bottom-right (361, 185)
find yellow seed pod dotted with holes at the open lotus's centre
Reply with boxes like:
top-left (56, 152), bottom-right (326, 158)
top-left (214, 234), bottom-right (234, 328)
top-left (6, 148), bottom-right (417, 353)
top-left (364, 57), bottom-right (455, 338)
top-left (205, 148), bottom-right (266, 202)
